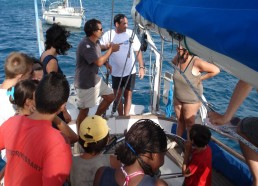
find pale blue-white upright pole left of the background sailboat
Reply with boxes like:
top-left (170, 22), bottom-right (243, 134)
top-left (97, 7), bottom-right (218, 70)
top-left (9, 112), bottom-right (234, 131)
top-left (34, 0), bottom-right (44, 56)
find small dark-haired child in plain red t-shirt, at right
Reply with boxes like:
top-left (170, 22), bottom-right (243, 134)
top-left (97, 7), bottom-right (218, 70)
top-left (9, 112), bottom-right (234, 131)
top-left (182, 124), bottom-right (212, 186)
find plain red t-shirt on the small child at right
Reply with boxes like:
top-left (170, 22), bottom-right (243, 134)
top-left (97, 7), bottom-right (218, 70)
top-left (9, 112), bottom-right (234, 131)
top-left (185, 146), bottom-right (212, 186)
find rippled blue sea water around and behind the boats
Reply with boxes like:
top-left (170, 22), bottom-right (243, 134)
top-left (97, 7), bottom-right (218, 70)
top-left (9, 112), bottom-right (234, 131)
top-left (0, 0), bottom-right (258, 151)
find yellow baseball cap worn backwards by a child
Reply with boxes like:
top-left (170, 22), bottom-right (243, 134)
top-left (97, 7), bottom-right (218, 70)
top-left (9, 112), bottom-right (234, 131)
top-left (79, 115), bottom-right (109, 147)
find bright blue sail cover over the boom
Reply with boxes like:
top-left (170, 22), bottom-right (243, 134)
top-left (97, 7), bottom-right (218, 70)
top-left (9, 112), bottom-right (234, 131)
top-left (136, 0), bottom-right (258, 71)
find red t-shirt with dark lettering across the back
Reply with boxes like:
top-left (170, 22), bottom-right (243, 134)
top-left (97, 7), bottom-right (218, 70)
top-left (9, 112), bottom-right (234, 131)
top-left (0, 115), bottom-right (72, 186)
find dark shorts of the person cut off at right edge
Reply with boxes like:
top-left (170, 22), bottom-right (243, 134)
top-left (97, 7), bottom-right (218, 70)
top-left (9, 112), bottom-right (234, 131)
top-left (239, 117), bottom-right (258, 145)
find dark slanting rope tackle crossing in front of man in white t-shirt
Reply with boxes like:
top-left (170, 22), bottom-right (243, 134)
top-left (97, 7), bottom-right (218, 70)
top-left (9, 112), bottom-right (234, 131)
top-left (111, 26), bottom-right (140, 117)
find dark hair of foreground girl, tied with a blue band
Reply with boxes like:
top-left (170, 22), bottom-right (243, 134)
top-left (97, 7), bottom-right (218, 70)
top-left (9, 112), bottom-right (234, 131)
top-left (115, 119), bottom-right (167, 176)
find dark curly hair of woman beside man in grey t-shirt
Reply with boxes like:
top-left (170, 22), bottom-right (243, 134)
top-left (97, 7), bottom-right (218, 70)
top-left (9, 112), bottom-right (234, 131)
top-left (45, 24), bottom-right (72, 55)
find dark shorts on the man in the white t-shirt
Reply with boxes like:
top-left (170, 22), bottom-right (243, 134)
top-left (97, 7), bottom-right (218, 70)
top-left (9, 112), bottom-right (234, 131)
top-left (112, 74), bottom-right (136, 90)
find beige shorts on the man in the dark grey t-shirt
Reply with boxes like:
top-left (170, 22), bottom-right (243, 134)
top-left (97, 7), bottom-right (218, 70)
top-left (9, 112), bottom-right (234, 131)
top-left (75, 79), bottom-right (113, 109)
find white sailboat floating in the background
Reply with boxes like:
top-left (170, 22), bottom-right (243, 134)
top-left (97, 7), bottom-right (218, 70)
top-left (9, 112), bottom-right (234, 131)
top-left (41, 0), bottom-right (84, 28)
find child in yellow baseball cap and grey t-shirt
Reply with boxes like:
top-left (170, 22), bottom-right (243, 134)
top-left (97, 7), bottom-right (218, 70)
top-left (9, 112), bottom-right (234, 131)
top-left (70, 115), bottom-right (121, 186)
